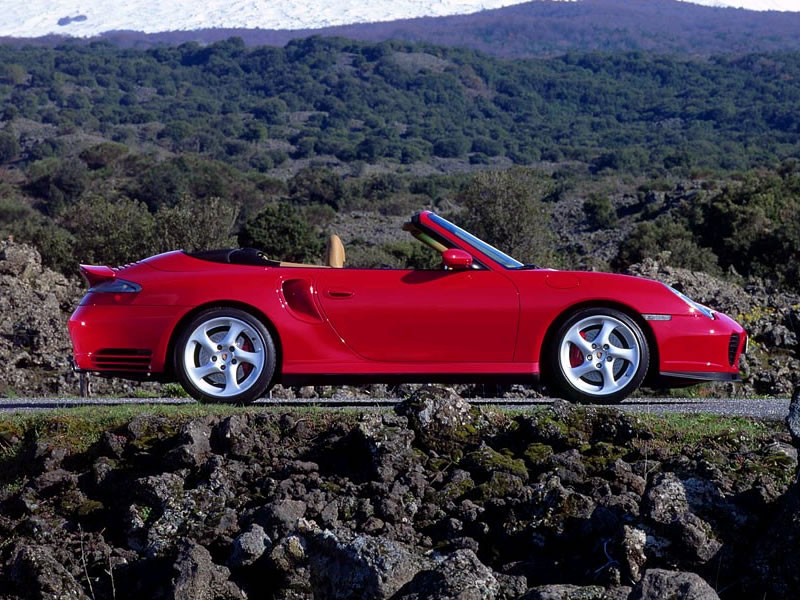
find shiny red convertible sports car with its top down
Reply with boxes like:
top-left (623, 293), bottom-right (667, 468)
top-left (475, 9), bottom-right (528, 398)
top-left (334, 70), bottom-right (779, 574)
top-left (69, 211), bottom-right (747, 403)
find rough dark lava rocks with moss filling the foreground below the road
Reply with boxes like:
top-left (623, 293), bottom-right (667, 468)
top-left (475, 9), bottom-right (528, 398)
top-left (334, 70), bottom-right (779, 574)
top-left (0, 388), bottom-right (800, 600)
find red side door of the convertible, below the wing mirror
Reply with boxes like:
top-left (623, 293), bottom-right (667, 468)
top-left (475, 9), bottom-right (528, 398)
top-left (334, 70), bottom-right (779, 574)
top-left (317, 269), bottom-right (519, 363)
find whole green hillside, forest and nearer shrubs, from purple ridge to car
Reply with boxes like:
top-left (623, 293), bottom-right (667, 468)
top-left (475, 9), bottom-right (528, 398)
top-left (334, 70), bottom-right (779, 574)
top-left (0, 38), bottom-right (800, 287)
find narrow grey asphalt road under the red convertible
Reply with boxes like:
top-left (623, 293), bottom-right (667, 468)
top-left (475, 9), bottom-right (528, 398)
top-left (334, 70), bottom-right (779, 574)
top-left (0, 397), bottom-right (789, 421)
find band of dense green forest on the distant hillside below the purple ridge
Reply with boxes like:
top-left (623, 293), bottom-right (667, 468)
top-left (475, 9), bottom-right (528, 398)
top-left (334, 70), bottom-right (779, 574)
top-left (0, 38), bottom-right (800, 172)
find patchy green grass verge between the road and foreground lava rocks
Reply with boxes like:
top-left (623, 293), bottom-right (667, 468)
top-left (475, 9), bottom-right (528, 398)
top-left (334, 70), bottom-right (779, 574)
top-left (0, 403), bottom-right (792, 489)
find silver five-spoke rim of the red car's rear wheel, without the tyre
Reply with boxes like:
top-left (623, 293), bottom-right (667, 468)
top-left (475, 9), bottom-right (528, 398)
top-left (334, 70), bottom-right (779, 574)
top-left (183, 317), bottom-right (266, 398)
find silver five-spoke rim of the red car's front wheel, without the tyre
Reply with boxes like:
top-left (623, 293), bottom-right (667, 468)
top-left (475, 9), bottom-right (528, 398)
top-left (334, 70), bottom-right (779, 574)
top-left (558, 315), bottom-right (641, 396)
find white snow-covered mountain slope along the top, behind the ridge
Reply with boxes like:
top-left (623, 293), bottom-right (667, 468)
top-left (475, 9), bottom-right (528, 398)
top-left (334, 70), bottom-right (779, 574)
top-left (0, 0), bottom-right (800, 37)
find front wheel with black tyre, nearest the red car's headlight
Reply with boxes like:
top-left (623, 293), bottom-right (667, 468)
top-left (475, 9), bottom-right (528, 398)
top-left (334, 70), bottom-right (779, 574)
top-left (548, 308), bottom-right (650, 403)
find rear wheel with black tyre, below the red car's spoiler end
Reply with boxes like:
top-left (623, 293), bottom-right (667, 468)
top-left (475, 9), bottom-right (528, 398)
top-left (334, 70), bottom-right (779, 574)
top-left (173, 308), bottom-right (275, 404)
